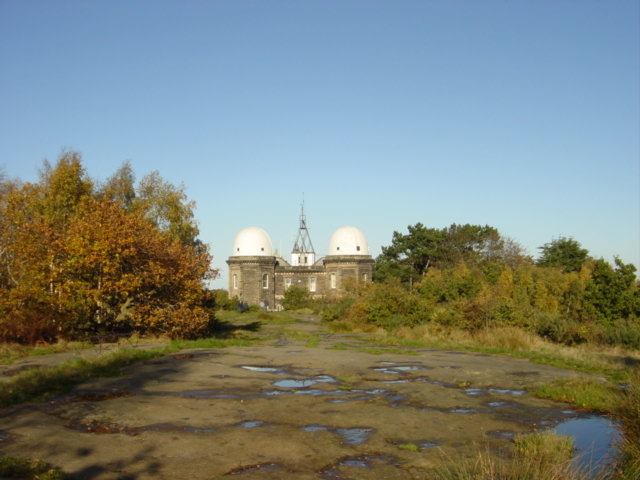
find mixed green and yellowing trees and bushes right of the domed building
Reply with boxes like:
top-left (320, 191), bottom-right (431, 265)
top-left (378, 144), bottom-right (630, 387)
top-left (323, 223), bottom-right (640, 348)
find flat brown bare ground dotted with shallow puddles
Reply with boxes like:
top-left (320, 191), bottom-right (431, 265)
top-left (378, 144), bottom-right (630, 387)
top-left (0, 317), bottom-right (592, 480)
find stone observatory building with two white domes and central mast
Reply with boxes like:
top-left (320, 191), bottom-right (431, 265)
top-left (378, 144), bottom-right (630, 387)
top-left (227, 207), bottom-right (373, 310)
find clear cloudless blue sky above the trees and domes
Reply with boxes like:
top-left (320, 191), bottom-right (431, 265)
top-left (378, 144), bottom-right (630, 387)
top-left (0, 0), bottom-right (640, 286)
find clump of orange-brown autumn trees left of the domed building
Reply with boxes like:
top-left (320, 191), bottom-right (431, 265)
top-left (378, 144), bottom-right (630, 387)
top-left (0, 152), bottom-right (216, 343)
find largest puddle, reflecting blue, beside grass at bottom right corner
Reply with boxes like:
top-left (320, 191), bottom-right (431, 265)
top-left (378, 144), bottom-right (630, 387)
top-left (554, 415), bottom-right (622, 470)
